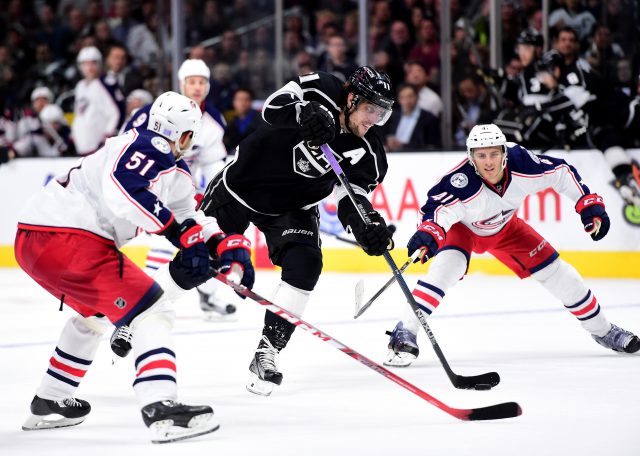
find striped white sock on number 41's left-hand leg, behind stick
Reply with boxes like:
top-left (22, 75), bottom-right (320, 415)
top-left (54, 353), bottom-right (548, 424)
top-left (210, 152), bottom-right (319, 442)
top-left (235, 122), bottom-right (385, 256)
top-left (402, 249), bottom-right (467, 334)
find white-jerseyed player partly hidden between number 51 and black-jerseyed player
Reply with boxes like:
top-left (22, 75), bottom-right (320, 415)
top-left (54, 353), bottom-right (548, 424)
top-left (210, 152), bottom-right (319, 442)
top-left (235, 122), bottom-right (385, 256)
top-left (123, 59), bottom-right (239, 321)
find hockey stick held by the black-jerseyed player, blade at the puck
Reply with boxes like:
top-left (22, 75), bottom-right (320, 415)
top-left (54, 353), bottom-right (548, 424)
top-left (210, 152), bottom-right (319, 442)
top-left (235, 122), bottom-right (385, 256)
top-left (320, 144), bottom-right (500, 390)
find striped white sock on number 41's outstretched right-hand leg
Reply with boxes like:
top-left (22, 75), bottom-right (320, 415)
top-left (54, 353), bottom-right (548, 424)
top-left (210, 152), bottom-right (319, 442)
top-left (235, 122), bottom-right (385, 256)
top-left (532, 258), bottom-right (611, 337)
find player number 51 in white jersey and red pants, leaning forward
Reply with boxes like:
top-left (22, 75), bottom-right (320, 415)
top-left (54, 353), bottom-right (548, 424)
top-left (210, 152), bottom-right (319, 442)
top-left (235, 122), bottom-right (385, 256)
top-left (15, 92), bottom-right (254, 443)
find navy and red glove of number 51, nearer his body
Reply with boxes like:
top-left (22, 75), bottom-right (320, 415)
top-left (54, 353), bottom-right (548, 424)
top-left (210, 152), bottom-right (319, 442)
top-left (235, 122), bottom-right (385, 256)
top-left (169, 219), bottom-right (211, 290)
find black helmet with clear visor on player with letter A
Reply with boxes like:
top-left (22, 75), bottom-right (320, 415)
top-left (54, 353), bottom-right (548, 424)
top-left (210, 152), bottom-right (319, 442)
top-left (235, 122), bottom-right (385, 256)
top-left (345, 66), bottom-right (394, 125)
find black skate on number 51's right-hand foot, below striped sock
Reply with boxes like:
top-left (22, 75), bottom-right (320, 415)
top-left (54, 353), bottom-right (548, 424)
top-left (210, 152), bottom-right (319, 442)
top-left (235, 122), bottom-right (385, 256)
top-left (142, 400), bottom-right (220, 443)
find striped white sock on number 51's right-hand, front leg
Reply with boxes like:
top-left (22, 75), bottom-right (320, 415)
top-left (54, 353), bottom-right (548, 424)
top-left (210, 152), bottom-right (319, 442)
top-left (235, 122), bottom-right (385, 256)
top-left (131, 295), bottom-right (178, 407)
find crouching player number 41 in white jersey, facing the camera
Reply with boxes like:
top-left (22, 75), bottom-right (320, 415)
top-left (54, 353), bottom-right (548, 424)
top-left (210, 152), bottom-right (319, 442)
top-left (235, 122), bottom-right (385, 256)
top-left (384, 124), bottom-right (640, 366)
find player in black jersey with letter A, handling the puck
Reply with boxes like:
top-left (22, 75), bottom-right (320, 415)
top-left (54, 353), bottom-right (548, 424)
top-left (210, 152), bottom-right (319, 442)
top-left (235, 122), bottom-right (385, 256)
top-left (201, 67), bottom-right (393, 396)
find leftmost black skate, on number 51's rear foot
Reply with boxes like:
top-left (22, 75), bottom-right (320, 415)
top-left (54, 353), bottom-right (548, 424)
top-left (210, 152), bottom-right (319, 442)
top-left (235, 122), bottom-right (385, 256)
top-left (22, 396), bottom-right (91, 431)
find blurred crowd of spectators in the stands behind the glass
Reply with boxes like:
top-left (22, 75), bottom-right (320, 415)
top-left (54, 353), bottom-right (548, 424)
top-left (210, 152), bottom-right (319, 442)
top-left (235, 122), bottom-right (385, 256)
top-left (0, 0), bottom-right (640, 160)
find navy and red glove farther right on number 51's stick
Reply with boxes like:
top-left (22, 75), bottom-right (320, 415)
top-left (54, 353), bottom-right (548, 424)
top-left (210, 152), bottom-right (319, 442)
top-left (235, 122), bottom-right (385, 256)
top-left (216, 234), bottom-right (256, 290)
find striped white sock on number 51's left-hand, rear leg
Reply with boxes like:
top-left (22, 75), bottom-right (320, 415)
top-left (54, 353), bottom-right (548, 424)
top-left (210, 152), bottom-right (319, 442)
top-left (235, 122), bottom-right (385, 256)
top-left (36, 315), bottom-right (110, 400)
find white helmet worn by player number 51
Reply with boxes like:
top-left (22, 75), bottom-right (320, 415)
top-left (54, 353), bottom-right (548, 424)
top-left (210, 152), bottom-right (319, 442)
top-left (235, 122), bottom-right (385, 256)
top-left (147, 92), bottom-right (202, 158)
